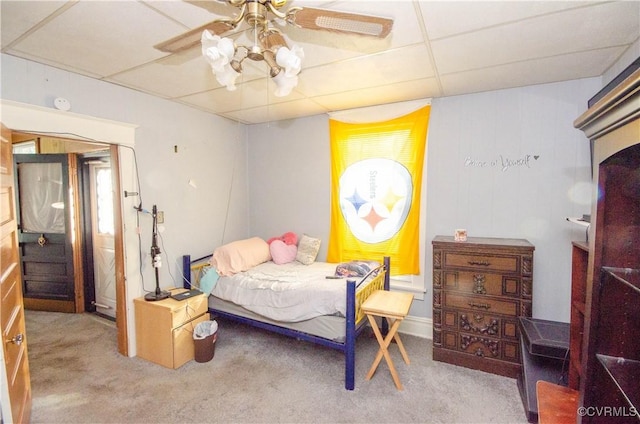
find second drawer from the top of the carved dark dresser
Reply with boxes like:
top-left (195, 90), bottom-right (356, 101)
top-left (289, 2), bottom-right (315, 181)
top-left (442, 270), bottom-right (522, 297)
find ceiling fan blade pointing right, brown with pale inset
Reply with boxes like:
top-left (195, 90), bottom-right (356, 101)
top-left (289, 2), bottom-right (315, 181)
top-left (287, 7), bottom-right (393, 38)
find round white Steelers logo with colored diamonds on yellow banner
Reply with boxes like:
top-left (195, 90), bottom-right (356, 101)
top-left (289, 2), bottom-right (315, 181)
top-left (339, 159), bottom-right (413, 243)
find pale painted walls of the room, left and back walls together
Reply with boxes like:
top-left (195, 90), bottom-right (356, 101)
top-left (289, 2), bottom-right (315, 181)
top-left (2, 51), bottom-right (616, 328)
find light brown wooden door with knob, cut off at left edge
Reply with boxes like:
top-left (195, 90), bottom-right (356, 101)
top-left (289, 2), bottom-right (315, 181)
top-left (0, 125), bottom-right (31, 423)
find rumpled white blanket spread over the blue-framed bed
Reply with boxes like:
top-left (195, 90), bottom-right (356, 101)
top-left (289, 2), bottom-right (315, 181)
top-left (211, 261), bottom-right (347, 322)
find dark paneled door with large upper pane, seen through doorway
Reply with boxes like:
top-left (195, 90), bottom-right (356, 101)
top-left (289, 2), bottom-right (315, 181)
top-left (14, 154), bottom-right (84, 312)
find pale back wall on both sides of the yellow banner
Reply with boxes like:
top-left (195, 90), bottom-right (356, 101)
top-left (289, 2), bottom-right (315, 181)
top-left (249, 78), bottom-right (601, 322)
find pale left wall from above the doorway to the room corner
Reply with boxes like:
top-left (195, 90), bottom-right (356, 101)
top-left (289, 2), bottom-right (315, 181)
top-left (0, 55), bottom-right (249, 354)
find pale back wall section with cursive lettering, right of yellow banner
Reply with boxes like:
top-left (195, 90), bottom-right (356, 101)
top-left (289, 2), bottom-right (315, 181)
top-left (426, 78), bottom-right (600, 322)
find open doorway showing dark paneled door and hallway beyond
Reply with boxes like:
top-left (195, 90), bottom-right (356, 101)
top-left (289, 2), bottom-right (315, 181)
top-left (13, 132), bottom-right (124, 324)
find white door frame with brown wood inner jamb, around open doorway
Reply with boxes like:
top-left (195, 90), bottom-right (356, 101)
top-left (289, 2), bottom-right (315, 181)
top-left (0, 99), bottom-right (137, 356)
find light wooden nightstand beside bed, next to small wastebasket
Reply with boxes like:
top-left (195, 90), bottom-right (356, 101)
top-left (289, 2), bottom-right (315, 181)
top-left (134, 289), bottom-right (209, 369)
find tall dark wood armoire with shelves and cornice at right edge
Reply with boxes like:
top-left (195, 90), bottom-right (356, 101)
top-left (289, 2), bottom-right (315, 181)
top-left (571, 63), bottom-right (640, 423)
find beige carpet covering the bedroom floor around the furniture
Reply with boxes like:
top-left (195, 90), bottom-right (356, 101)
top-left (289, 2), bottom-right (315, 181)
top-left (26, 311), bottom-right (527, 423)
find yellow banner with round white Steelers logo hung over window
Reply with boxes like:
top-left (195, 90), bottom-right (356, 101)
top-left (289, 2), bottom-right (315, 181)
top-left (327, 106), bottom-right (431, 275)
